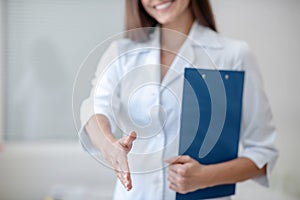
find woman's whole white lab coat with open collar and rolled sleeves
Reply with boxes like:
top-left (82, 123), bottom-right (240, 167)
top-left (80, 22), bottom-right (277, 200)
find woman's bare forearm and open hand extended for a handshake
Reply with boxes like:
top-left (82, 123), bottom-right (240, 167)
top-left (85, 114), bottom-right (136, 190)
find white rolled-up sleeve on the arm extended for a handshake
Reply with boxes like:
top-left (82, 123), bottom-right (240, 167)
top-left (79, 42), bottom-right (119, 154)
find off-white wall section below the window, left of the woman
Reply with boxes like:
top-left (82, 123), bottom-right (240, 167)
top-left (0, 143), bottom-right (115, 200)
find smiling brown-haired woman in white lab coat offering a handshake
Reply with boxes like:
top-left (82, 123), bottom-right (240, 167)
top-left (81, 0), bottom-right (277, 200)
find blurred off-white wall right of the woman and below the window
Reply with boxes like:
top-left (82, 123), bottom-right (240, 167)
top-left (0, 0), bottom-right (300, 200)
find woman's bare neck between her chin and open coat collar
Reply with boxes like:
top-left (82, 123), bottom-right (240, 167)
top-left (160, 9), bottom-right (194, 52)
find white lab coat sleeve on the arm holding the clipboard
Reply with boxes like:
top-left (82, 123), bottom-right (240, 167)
top-left (239, 43), bottom-right (278, 186)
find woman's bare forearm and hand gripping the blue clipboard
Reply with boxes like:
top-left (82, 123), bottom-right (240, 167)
top-left (166, 156), bottom-right (266, 194)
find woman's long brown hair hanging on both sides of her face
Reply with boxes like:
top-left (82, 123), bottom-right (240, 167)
top-left (125, 0), bottom-right (217, 31)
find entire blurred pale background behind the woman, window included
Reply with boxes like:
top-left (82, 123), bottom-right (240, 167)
top-left (0, 0), bottom-right (300, 200)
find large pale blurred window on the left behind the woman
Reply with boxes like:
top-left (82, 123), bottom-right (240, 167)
top-left (2, 0), bottom-right (124, 141)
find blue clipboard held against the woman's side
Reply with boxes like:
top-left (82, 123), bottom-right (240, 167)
top-left (176, 68), bottom-right (244, 200)
